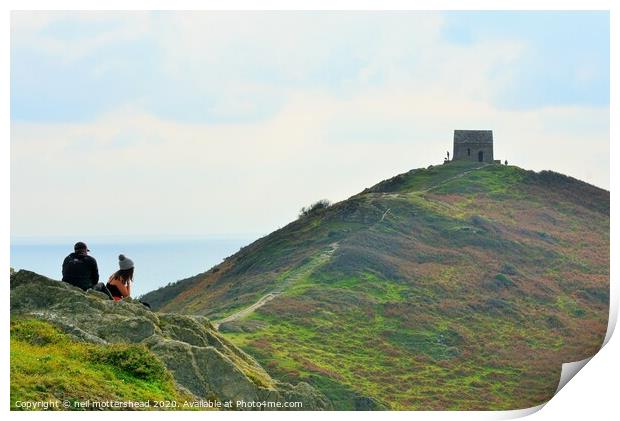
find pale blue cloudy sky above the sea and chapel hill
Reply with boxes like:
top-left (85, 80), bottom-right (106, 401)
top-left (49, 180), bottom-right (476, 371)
top-left (10, 11), bottom-right (610, 238)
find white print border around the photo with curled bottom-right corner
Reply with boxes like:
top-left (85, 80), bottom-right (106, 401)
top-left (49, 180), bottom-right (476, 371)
top-left (0, 0), bottom-right (620, 420)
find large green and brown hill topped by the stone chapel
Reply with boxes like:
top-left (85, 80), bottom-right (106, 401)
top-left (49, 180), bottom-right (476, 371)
top-left (144, 162), bottom-right (609, 409)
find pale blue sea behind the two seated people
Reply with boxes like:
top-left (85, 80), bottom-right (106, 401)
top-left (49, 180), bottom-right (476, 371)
top-left (10, 235), bottom-right (259, 297)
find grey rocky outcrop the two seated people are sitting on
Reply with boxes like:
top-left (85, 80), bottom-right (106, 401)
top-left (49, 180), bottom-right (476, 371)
top-left (11, 270), bottom-right (329, 410)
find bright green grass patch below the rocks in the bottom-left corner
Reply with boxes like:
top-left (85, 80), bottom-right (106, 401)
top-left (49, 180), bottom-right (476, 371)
top-left (10, 318), bottom-right (192, 410)
